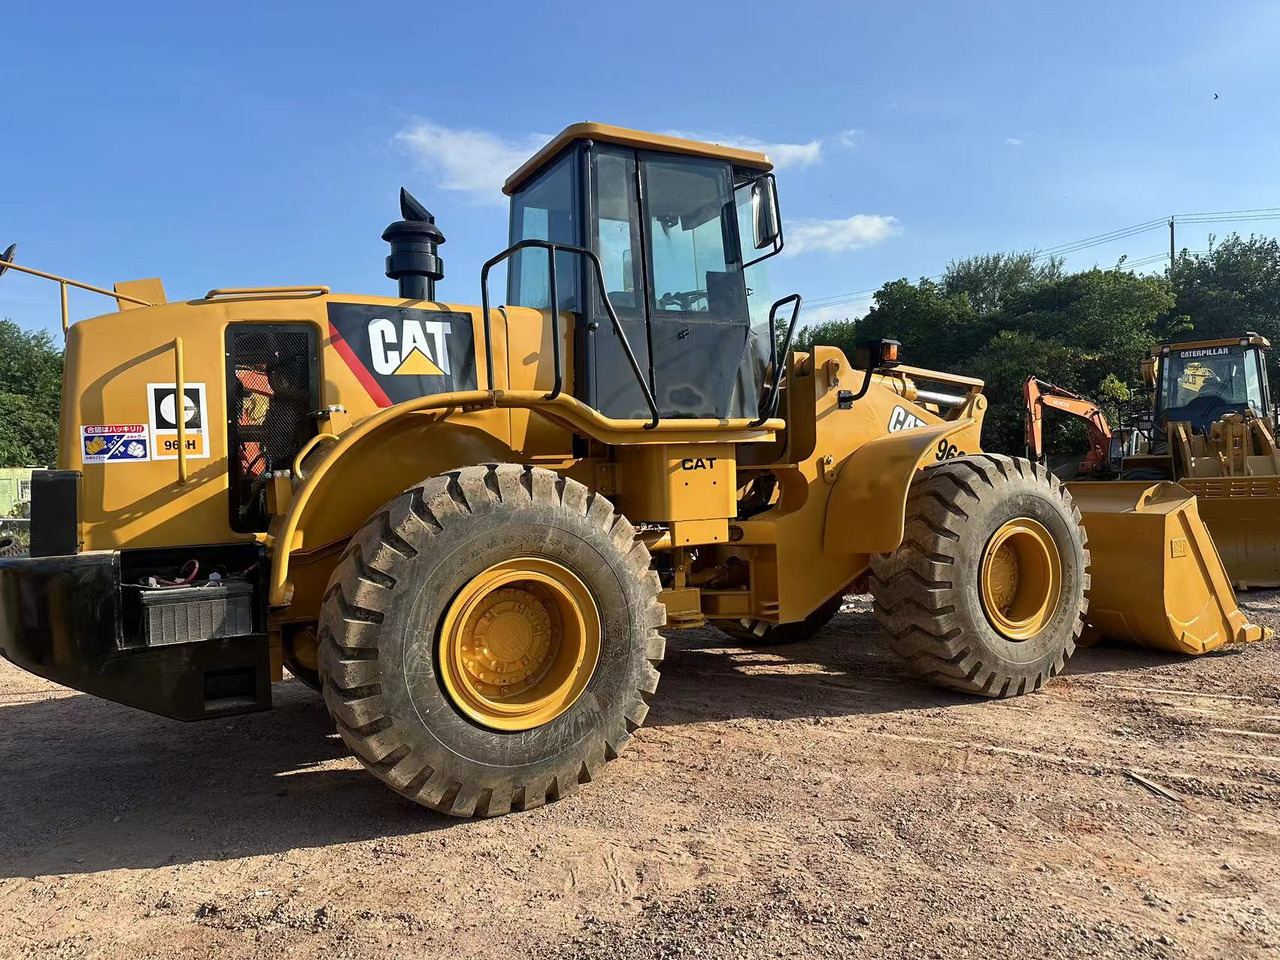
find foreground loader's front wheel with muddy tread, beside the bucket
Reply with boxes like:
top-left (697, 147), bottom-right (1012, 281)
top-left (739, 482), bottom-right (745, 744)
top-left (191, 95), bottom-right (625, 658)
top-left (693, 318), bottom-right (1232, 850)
top-left (870, 454), bottom-right (1089, 696)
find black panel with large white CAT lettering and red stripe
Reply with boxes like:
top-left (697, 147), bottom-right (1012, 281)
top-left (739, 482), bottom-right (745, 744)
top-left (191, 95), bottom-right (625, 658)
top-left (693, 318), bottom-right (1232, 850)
top-left (329, 303), bottom-right (476, 407)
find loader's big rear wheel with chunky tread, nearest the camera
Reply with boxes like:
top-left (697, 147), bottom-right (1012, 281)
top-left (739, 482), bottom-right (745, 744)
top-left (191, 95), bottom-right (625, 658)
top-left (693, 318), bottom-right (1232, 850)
top-left (320, 463), bottom-right (664, 817)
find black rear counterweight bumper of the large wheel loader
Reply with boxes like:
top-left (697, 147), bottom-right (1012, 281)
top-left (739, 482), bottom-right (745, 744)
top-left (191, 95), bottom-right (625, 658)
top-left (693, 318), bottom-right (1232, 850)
top-left (0, 544), bottom-right (271, 721)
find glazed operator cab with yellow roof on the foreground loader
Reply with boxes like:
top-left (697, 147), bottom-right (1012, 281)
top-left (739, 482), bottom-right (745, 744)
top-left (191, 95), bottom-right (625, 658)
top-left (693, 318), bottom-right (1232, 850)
top-left (503, 123), bottom-right (782, 419)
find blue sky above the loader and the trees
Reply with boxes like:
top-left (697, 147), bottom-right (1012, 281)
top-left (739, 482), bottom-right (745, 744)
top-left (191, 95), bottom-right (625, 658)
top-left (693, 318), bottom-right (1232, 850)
top-left (0, 0), bottom-right (1280, 329)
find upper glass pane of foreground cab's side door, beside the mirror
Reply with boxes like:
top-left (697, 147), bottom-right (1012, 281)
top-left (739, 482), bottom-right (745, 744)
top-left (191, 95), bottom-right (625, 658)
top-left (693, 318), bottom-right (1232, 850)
top-left (643, 156), bottom-right (748, 321)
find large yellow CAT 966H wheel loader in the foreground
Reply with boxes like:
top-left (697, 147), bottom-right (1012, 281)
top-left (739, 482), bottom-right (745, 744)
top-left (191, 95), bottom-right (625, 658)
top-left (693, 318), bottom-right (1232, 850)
top-left (0, 124), bottom-right (1261, 815)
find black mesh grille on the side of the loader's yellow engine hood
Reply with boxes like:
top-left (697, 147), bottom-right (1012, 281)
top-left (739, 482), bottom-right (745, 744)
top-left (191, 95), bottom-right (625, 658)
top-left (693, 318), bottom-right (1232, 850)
top-left (227, 324), bottom-right (319, 532)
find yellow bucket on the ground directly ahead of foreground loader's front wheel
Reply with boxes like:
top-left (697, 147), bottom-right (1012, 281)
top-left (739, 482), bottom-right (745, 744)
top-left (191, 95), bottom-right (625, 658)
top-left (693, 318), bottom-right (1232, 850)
top-left (1068, 481), bottom-right (1266, 654)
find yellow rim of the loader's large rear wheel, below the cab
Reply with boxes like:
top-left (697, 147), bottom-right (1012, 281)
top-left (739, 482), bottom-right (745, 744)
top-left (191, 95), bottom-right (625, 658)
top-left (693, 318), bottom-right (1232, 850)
top-left (439, 557), bottom-right (600, 730)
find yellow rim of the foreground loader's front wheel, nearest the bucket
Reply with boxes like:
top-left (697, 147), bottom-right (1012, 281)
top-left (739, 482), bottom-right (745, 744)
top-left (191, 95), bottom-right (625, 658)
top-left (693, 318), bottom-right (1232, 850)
top-left (979, 517), bottom-right (1062, 640)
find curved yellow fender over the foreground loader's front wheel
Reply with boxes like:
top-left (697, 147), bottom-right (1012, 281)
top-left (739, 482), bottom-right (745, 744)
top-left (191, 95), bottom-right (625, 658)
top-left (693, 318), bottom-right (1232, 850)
top-left (822, 417), bottom-right (982, 553)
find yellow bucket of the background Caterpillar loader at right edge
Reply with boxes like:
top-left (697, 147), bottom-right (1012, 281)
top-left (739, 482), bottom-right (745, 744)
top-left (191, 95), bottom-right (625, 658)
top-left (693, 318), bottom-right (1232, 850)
top-left (1180, 476), bottom-right (1280, 589)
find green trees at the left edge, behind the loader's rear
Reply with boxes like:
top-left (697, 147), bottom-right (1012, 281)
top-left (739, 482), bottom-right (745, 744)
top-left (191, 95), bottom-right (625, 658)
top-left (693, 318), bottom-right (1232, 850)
top-left (0, 320), bottom-right (63, 467)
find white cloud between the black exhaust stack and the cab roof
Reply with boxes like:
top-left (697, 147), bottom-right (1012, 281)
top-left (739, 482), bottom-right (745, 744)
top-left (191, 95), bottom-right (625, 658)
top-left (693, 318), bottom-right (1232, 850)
top-left (396, 120), bottom-right (550, 204)
